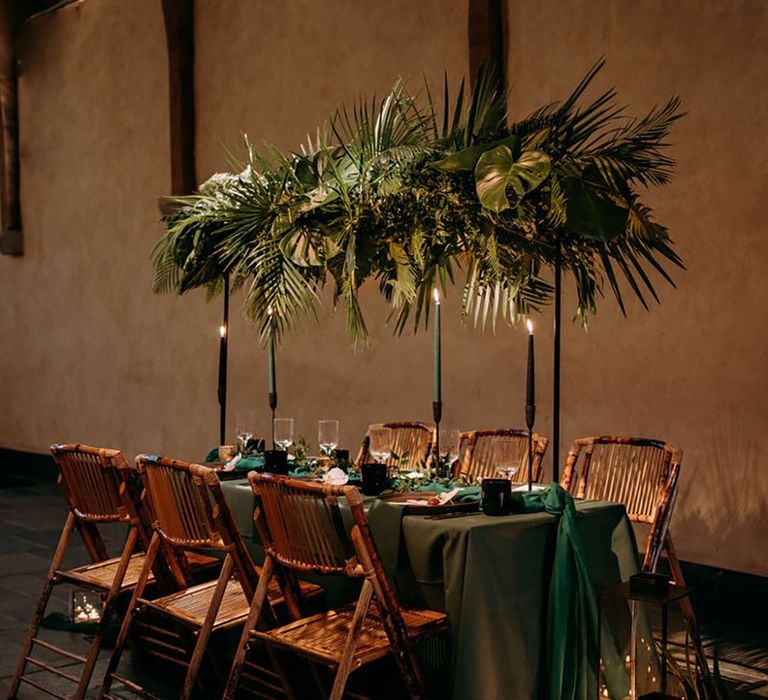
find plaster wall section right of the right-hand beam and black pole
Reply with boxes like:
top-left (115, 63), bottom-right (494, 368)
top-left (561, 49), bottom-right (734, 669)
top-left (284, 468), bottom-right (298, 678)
top-left (509, 0), bottom-right (768, 574)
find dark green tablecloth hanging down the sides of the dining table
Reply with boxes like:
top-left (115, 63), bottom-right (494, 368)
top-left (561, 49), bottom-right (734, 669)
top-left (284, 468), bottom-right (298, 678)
top-left (222, 481), bottom-right (637, 700)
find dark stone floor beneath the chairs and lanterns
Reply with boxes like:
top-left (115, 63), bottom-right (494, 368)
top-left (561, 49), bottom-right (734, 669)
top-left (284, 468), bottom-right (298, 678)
top-left (0, 477), bottom-right (768, 700)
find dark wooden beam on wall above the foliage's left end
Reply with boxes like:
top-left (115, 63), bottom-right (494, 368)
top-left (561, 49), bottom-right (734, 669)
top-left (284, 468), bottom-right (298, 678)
top-left (162, 0), bottom-right (197, 195)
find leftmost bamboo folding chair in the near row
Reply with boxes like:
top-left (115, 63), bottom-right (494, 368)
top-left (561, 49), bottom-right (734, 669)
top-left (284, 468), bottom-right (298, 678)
top-left (8, 444), bottom-right (159, 699)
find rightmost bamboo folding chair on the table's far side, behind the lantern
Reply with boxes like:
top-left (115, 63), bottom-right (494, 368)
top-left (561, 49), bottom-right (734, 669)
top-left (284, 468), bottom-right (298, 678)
top-left (562, 436), bottom-right (693, 619)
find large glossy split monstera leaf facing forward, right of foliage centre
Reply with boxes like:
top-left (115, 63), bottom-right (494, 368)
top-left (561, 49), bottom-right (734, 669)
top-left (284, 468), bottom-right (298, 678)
top-left (475, 145), bottom-right (552, 213)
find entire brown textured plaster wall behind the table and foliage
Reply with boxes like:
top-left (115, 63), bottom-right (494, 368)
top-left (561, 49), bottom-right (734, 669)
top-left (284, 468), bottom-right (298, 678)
top-left (0, 0), bottom-right (768, 574)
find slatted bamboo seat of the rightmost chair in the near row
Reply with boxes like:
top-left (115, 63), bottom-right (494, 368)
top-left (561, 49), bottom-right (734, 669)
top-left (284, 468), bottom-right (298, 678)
top-left (251, 605), bottom-right (447, 668)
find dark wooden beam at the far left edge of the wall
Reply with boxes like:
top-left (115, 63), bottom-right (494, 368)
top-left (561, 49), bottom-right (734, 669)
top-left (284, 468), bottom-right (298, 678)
top-left (0, 2), bottom-right (24, 255)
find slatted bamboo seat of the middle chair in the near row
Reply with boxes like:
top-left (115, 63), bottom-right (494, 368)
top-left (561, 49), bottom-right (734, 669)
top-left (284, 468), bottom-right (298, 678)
top-left (144, 578), bottom-right (322, 630)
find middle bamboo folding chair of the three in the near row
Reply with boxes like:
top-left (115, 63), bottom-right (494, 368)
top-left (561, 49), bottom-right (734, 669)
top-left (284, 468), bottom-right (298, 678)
top-left (99, 455), bottom-right (320, 699)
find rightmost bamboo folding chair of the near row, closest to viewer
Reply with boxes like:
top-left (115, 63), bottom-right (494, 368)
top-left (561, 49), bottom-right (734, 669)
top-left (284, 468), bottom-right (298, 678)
top-left (224, 472), bottom-right (447, 700)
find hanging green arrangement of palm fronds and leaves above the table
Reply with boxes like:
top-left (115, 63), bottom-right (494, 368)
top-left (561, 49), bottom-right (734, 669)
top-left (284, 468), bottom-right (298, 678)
top-left (154, 61), bottom-right (682, 343)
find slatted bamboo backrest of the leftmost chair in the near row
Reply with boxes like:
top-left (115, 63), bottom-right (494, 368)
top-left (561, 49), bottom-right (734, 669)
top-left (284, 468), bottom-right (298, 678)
top-left (51, 444), bottom-right (130, 523)
